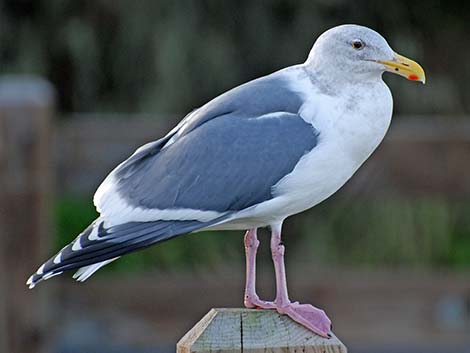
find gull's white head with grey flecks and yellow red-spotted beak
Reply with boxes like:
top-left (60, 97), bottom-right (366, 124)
top-left (305, 25), bottom-right (425, 83)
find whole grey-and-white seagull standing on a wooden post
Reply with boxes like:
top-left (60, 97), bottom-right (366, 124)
top-left (27, 25), bottom-right (425, 337)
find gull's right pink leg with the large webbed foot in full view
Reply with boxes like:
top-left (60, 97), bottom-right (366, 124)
top-left (271, 224), bottom-right (331, 337)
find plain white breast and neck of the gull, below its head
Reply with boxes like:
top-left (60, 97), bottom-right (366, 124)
top-left (274, 72), bottom-right (393, 214)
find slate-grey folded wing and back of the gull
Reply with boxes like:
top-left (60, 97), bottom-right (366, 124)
top-left (97, 70), bottom-right (318, 212)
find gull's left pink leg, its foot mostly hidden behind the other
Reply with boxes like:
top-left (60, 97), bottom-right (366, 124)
top-left (244, 228), bottom-right (276, 309)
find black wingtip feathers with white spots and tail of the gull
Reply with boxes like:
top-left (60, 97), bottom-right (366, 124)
top-left (26, 218), bottom-right (220, 288)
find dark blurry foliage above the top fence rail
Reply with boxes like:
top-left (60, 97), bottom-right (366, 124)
top-left (0, 0), bottom-right (470, 114)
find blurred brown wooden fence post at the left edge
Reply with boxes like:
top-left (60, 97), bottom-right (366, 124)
top-left (0, 76), bottom-right (54, 353)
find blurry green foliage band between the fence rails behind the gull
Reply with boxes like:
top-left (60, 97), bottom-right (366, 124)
top-left (55, 192), bottom-right (470, 271)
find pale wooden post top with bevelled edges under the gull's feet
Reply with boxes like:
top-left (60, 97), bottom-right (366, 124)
top-left (176, 309), bottom-right (347, 353)
